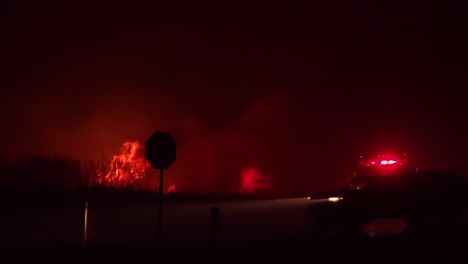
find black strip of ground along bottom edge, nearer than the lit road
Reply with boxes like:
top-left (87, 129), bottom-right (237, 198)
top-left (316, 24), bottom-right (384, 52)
top-left (2, 230), bottom-right (468, 263)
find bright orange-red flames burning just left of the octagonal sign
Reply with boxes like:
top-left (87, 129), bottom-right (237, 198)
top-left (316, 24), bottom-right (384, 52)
top-left (97, 141), bottom-right (147, 188)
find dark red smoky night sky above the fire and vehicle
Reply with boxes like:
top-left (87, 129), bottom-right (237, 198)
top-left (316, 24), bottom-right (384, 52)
top-left (0, 0), bottom-right (468, 192)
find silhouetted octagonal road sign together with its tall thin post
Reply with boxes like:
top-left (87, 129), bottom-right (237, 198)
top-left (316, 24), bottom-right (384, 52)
top-left (145, 131), bottom-right (176, 241)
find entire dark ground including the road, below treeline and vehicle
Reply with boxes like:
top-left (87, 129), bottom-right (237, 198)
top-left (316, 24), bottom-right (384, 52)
top-left (1, 190), bottom-right (468, 263)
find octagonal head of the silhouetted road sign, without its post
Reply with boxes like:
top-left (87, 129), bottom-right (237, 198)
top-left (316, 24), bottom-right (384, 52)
top-left (145, 131), bottom-right (176, 170)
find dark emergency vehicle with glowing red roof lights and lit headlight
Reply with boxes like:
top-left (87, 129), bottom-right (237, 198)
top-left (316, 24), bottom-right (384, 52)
top-left (308, 154), bottom-right (467, 231)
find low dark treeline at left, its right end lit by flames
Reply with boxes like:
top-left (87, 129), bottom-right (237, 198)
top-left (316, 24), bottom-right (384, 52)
top-left (0, 155), bottom-right (151, 191)
